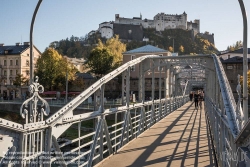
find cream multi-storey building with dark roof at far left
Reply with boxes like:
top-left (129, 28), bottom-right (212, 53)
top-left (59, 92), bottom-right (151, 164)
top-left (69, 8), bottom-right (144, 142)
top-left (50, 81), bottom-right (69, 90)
top-left (0, 42), bottom-right (41, 99)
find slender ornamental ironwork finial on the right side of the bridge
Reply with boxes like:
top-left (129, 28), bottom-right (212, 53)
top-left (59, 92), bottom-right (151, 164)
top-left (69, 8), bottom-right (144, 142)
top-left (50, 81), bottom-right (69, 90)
top-left (236, 74), bottom-right (245, 130)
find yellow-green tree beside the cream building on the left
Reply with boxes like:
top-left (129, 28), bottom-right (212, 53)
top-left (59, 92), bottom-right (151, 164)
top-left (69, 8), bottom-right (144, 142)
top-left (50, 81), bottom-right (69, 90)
top-left (35, 48), bottom-right (77, 90)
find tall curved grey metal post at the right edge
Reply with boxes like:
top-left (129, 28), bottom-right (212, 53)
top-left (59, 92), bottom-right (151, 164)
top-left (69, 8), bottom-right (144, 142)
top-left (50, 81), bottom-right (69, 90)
top-left (238, 0), bottom-right (248, 124)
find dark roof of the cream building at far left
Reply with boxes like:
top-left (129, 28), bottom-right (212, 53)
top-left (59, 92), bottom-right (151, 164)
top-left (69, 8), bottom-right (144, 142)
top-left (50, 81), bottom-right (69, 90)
top-left (0, 45), bottom-right (41, 55)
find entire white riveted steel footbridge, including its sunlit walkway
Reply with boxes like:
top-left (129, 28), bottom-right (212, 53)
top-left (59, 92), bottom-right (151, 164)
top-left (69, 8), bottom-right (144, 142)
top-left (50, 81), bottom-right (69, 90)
top-left (0, 55), bottom-right (250, 167)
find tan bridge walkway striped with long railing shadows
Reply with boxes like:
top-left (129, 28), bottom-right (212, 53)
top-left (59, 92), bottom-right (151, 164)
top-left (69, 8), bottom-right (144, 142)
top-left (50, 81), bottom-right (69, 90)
top-left (99, 102), bottom-right (215, 167)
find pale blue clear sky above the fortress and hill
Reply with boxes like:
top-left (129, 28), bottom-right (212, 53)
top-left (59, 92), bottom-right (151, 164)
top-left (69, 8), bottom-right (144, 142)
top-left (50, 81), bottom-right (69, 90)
top-left (0, 0), bottom-right (250, 52)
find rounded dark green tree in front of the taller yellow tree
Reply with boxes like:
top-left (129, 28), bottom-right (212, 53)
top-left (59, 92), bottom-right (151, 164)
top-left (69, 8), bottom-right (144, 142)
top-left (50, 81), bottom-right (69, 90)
top-left (87, 47), bottom-right (115, 76)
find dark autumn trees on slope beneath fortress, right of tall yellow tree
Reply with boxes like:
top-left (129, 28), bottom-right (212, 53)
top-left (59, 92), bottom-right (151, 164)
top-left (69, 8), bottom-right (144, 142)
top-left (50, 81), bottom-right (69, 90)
top-left (126, 28), bottom-right (218, 55)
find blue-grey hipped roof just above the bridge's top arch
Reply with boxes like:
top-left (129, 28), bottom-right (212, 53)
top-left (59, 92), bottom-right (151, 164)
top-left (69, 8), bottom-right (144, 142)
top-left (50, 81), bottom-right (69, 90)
top-left (123, 45), bottom-right (168, 54)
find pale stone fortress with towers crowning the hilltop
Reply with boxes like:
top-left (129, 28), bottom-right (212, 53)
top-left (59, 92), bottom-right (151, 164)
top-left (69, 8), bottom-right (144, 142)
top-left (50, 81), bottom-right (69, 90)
top-left (92, 12), bottom-right (214, 43)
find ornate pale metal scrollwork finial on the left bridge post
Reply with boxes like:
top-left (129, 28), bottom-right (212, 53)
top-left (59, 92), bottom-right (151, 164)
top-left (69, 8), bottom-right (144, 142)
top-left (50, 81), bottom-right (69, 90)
top-left (20, 76), bottom-right (50, 123)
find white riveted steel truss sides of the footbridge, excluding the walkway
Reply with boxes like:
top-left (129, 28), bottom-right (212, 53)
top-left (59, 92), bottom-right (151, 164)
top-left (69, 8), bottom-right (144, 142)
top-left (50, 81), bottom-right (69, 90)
top-left (0, 55), bottom-right (249, 167)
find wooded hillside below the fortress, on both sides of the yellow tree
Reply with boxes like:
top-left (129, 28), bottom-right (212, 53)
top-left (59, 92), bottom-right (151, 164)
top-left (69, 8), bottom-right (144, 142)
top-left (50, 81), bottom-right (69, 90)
top-left (49, 29), bottom-right (218, 58)
